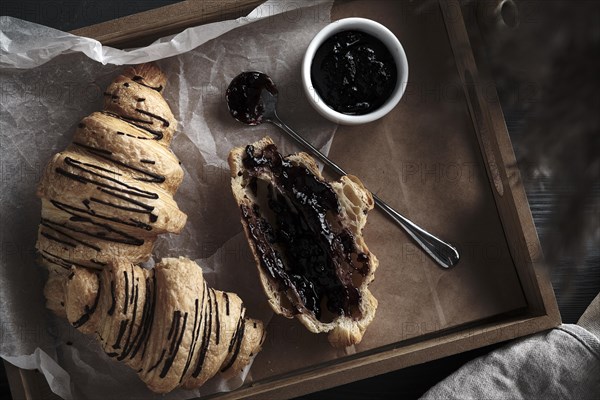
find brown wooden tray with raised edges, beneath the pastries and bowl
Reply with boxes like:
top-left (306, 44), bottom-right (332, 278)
top-left (5, 0), bottom-right (561, 399)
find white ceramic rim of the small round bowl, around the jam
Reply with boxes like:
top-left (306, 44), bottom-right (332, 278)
top-left (302, 18), bottom-right (408, 125)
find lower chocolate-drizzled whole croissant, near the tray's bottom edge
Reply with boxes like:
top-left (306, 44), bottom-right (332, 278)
top-left (65, 257), bottom-right (264, 393)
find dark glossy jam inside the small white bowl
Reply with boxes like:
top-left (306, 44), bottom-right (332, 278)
top-left (310, 31), bottom-right (398, 115)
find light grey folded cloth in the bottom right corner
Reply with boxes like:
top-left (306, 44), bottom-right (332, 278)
top-left (421, 294), bottom-right (600, 400)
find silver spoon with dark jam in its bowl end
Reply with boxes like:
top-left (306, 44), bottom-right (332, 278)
top-left (225, 71), bottom-right (460, 268)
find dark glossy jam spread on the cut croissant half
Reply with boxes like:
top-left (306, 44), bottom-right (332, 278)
top-left (241, 144), bottom-right (369, 320)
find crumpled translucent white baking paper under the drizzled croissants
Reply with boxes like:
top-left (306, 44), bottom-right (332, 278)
top-left (0, 1), bottom-right (336, 399)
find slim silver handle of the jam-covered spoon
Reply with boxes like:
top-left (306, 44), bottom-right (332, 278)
top-left (268, 115), bottom-right (460, 268)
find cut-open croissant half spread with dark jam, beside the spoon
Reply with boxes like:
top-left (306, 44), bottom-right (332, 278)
top-left (229, 137), bottom-right (379, 347)
